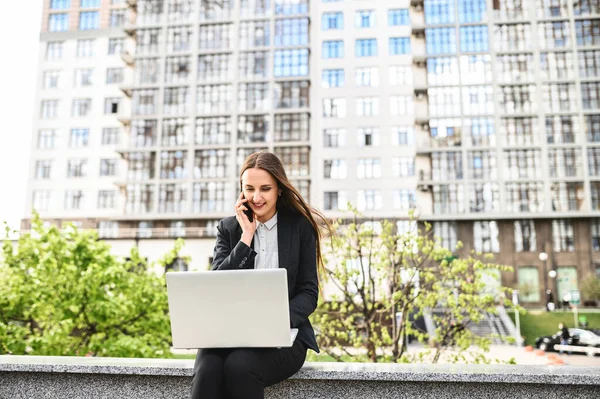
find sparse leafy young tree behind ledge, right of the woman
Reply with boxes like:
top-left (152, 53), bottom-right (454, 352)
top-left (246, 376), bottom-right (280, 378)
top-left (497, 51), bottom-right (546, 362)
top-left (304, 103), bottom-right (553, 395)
top-left (313, 207), bottom-right (508, 362)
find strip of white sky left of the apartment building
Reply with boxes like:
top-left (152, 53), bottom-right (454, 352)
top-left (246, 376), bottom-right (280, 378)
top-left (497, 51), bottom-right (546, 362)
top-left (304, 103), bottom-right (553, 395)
top-left (0, 0), bottom-right (43, 233)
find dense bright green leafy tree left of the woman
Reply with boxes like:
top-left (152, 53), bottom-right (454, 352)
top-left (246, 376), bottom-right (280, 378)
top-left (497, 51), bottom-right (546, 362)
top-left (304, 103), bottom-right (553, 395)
top-left (0, 216), bottom-right (182, 357)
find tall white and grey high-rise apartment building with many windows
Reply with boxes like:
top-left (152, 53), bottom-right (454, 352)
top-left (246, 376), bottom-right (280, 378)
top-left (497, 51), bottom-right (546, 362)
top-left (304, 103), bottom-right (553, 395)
top-left (24, 0), bottom-right (600, 304)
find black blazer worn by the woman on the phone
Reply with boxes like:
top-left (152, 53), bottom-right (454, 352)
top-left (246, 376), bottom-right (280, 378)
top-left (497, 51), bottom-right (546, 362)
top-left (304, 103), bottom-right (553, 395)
top-left (211, 211), bottom-right (319, 353)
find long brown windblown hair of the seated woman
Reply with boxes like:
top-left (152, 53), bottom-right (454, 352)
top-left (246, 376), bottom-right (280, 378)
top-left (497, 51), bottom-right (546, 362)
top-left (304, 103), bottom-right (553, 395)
top-left (240, 151), bottom-right (332, 277)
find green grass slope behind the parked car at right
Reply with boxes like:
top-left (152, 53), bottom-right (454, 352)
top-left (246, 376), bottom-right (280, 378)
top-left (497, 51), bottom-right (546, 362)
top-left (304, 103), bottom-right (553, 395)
top-left (508, 310), bottom-right (600, 345)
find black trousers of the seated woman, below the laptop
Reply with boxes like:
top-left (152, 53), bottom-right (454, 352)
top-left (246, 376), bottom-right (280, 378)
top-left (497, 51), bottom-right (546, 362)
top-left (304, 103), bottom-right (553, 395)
top-left (192, 339), bottom-right (306, 399)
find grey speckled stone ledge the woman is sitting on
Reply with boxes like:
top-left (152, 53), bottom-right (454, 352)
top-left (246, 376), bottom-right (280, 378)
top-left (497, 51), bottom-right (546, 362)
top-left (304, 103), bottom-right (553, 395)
top-left (0, 356), bottom-right (600, 399)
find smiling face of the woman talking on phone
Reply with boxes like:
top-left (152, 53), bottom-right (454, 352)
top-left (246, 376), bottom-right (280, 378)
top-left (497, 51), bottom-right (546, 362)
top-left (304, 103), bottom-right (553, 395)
top-left (242, 168), bottom-right (279, 223)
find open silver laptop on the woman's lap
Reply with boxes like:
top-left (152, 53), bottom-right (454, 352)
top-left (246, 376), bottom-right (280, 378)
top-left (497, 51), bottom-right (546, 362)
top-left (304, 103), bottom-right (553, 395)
top-left (166, 269), bottom-right (298, 349)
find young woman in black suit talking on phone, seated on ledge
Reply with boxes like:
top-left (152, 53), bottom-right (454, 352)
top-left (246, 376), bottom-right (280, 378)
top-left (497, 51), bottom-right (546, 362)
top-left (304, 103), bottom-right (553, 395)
top-left (192, 152), bottom-right (330, 399)
